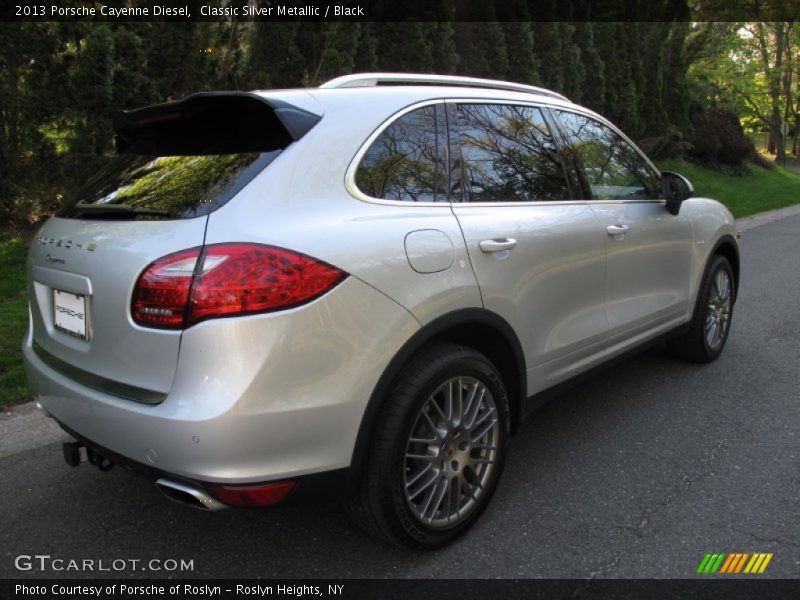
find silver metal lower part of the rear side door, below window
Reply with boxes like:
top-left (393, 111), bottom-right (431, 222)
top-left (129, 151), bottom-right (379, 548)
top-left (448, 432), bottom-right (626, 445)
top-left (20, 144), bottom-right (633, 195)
top-left (453, 202), bottom-right (608, 380)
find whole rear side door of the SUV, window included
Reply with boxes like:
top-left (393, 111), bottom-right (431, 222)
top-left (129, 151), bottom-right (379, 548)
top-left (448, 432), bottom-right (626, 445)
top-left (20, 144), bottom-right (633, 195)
top-left (449, 102), bottom-right (608, 393)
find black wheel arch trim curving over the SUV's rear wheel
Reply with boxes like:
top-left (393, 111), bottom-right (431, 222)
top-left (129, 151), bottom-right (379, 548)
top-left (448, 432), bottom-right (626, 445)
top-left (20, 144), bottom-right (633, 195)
top-left (349, 308), bottom-right (527, 483)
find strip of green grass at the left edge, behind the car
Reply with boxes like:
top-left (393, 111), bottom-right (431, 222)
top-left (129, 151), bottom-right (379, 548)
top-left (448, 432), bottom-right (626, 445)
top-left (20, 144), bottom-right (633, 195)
top-left (0, 233), bottom-right (31, 406)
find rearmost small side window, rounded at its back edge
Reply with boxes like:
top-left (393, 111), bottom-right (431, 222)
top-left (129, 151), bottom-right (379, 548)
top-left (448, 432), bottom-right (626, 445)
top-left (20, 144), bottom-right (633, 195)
top-left (356, 105), bottom-right (447, 202)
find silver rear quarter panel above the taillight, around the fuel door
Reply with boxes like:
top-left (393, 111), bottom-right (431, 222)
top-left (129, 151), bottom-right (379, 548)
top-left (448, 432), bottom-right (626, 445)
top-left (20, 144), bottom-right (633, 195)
top-left (206, 90), bottom-right (481, 324)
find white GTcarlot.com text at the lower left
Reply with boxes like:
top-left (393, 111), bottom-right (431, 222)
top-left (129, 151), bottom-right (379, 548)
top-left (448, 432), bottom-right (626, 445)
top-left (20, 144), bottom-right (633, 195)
top-left (14, 554), bottom-right (194, 573)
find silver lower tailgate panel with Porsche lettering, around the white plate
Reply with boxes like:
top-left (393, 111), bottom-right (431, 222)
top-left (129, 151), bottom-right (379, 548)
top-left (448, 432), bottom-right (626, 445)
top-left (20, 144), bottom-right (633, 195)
top-left (28, 217), bottom-right (206, 393)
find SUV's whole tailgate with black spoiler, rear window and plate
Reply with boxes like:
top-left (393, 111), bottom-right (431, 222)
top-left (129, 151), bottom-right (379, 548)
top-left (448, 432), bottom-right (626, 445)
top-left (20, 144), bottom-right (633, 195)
top-left (27, 94), bottom-right (316, 403)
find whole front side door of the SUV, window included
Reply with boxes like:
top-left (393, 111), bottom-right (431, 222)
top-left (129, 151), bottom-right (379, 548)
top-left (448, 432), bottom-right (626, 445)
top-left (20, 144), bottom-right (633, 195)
top-left (556, 111), bottom-right (692, 350)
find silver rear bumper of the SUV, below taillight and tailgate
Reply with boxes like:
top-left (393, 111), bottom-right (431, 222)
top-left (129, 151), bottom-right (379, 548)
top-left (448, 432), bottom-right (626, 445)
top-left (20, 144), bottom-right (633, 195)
top-left (23, 277), bottom-right (418, 485)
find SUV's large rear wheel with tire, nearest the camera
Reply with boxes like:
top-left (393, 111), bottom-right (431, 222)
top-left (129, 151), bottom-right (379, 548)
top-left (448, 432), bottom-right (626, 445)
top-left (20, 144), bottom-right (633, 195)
top-left (346, 343), bottom-right (510, 549)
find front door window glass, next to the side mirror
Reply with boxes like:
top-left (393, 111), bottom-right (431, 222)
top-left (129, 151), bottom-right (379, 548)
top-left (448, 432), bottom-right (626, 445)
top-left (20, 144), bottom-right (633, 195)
top-left (558, 111), bottom-right (660, 200)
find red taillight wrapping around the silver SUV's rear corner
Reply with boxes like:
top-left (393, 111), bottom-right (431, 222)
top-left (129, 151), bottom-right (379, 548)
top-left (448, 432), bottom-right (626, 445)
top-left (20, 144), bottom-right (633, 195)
top-left (132, 244), bottom-right (346, 329)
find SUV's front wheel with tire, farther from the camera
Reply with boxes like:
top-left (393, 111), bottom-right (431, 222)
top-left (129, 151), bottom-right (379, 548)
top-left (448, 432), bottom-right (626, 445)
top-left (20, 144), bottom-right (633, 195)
top-left (667, 254), bottom-right (736, 363)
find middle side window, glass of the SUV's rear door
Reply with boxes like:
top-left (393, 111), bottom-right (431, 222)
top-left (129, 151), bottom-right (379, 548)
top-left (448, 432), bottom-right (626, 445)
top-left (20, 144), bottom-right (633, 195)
top-left (456, 104), bottom-right (570, 202)
